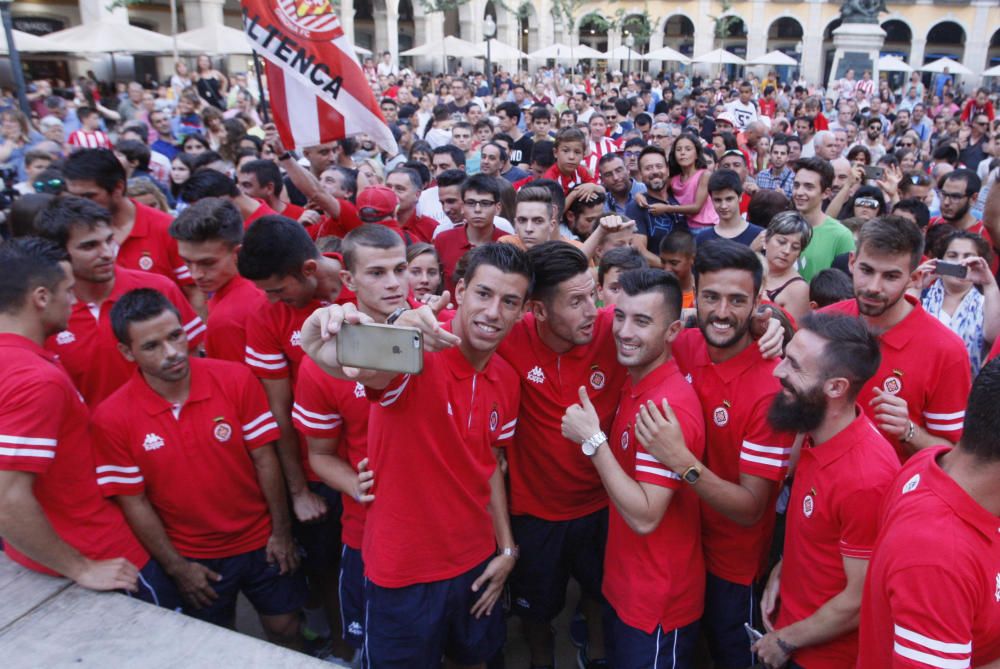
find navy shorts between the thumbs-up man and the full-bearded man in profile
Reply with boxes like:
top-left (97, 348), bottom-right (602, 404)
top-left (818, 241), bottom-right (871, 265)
top-left (701, 574), bottom-right (761, 669)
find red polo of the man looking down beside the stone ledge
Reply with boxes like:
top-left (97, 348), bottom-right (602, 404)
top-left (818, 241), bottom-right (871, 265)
top-left (93, 358), bottom-right (278, 559)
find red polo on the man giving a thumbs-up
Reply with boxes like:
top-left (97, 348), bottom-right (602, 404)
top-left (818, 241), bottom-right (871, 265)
top-left (596, 359), bottom-right (705, 634)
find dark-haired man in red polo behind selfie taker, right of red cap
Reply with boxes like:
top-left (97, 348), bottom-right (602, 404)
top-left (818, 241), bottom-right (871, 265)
top-left (434, 174), bottom-right (504, 290)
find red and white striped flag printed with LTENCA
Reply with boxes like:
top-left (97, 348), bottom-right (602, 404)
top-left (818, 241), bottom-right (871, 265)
top-left (241, 0), bottom-right (398, 153)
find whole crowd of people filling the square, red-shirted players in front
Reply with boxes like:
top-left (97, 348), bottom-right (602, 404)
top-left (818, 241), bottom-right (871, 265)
top-left (0, 54), bottom-right (1000, 669)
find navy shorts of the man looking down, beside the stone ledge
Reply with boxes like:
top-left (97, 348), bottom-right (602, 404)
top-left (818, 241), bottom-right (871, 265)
top-left (184, 548), bottom-right (306, 627)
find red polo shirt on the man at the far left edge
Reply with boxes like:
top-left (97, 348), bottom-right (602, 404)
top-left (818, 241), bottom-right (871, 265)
top-left (0, 333), bottom-right (149, 574)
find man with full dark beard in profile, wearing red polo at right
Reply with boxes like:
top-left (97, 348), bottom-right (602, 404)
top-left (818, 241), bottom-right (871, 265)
top-left (752, 314), bottom-right (899, 669)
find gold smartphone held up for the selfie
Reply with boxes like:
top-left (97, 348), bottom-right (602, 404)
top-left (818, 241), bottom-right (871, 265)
top-left (337, 323), bottom-right (424, 374)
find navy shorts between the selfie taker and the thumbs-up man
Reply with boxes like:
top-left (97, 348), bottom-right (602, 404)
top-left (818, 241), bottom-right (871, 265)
top-left (510, 508), bottom-right (608, 622)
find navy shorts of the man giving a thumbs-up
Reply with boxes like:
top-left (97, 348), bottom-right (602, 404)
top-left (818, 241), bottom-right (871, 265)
top-left (608, 607), bottom-right (700, 669)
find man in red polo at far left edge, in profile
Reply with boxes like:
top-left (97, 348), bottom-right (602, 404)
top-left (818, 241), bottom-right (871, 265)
top-left (0, 237), bottom-right (155, 601)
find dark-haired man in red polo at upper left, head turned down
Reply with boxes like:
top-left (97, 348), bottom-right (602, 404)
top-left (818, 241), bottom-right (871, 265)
top-left (62, 149), bottom-right (204, 308)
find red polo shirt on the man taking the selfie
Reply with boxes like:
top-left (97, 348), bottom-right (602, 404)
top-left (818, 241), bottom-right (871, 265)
top-left (362, 348), bottom-right (519, 588)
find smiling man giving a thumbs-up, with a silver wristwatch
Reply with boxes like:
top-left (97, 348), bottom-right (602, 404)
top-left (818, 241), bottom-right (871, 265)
top-left (562, 269), bottom-right (705, 669)
